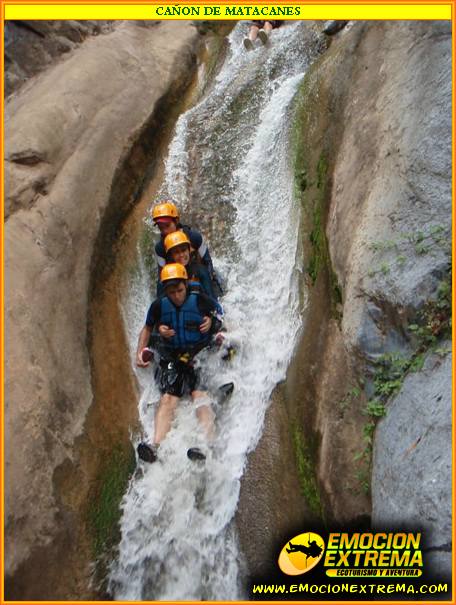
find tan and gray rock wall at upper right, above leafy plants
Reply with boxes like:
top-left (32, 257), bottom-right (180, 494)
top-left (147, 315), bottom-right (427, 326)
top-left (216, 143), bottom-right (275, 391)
top-left (327, 22), bottom-right (451, 354)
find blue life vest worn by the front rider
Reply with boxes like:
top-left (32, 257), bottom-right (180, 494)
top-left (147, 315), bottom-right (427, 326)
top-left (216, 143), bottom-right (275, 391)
top-left (160, 293), bottom-right (210, 350)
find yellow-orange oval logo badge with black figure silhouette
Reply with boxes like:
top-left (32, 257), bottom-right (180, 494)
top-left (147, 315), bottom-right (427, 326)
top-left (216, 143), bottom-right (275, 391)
top-left (279, 531), bottom-right (325, 576)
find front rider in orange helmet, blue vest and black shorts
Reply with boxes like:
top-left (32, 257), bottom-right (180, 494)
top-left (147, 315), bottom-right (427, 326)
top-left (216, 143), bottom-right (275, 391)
top-left (136, 263), bottom-right (228, 462)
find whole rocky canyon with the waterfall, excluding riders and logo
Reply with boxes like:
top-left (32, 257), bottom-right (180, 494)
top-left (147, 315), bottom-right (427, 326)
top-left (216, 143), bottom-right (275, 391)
top-left (6, 22), bottom-right (451, 600)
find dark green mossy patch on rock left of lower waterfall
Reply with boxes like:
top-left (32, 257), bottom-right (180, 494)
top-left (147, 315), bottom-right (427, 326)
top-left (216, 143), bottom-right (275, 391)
top-left (87, 445), bottom-right (135, 558)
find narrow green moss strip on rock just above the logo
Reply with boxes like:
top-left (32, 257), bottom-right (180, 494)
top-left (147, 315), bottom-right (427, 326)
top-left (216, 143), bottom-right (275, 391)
top-left (292, 424), bottom-right (323, 519)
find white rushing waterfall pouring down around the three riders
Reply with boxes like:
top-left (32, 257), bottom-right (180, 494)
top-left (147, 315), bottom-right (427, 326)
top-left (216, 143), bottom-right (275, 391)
top-left (109, 23), bottom-right (318, 600)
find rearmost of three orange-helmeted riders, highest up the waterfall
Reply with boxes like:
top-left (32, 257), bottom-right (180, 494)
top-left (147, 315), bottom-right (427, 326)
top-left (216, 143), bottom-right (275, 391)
top-left (151, 200), bottom-right (223, 298)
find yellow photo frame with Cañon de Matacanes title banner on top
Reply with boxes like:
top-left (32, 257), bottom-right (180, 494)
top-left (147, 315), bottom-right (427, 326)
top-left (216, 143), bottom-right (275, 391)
top-left (0, 0), bottom-right (456, 605)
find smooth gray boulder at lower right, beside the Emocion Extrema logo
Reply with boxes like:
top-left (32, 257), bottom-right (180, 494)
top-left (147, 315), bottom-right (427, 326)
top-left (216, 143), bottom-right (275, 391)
top-left (372, 342), bottom-right (452, 577)
